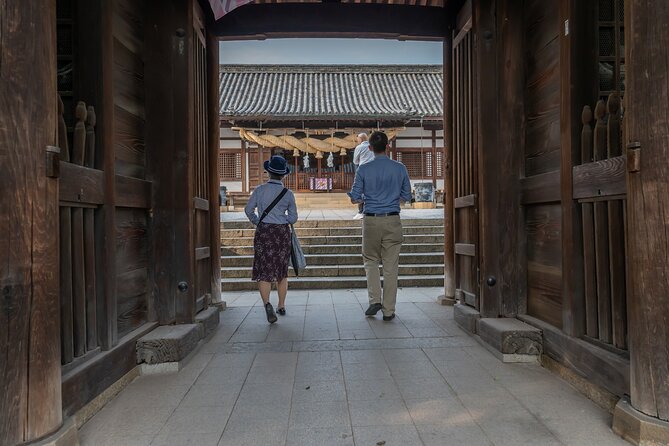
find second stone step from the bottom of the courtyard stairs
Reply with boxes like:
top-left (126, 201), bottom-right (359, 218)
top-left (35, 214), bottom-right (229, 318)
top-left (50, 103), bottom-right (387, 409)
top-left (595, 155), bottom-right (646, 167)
top-left (221, 264), bottom-right (444, 280)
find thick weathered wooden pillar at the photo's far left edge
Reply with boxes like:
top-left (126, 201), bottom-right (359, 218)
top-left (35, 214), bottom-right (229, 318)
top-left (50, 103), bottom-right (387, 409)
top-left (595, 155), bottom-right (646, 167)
top-left (0, 0), bottom-right (62, 445)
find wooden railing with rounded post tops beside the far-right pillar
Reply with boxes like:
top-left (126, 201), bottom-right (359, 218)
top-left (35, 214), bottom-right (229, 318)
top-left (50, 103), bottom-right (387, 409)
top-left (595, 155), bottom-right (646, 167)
top-left (573, 94), bottom-right (627, 351)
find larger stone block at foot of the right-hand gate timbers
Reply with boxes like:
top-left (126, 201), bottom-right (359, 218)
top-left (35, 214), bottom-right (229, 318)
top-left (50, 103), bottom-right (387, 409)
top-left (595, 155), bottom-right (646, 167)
top-left (479, 318), bottom-right (543, 356)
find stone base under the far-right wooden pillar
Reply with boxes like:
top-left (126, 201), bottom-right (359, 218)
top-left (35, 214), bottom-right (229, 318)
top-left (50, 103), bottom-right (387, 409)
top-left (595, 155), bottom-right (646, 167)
top-left (613, 397), bottom-right (669, 446)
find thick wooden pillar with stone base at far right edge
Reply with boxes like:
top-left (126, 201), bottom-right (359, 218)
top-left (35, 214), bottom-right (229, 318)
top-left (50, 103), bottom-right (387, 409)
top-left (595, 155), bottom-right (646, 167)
top-left (614, 0), bottom-right (669, 444)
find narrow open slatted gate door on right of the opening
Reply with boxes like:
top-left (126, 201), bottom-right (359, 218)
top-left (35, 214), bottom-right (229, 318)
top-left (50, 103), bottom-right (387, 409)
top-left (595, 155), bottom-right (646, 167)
top-left (449, 17), bottom-right (480, 310)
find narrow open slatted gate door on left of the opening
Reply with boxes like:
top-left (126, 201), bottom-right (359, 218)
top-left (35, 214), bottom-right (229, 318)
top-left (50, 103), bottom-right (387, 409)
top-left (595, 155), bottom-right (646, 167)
top-left (192, 6), bottom-right (210, 312)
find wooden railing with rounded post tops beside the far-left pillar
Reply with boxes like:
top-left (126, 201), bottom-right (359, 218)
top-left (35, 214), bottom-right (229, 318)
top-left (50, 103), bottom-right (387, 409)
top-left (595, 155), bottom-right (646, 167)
top-left (58, 97), bottom-right (104, 365)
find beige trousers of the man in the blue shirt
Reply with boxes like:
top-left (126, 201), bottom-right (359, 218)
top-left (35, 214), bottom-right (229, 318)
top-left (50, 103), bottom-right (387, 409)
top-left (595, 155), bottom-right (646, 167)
top-left (362, 215), bottom-right (404, 316)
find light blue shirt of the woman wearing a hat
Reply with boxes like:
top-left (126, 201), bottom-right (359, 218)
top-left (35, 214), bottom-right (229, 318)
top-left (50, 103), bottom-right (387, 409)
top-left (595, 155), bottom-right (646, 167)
top-left (244, 180), bottom-right (297, 225)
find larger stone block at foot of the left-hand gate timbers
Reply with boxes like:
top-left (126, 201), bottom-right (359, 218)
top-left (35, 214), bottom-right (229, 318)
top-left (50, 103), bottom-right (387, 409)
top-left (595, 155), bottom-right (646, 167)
top-left (136, 324), bottom-right (200, 364)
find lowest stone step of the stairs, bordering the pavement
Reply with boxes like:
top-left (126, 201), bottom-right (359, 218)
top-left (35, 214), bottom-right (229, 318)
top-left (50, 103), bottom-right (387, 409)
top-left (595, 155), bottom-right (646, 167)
top-left (221, 274), bottom-right (444, 292)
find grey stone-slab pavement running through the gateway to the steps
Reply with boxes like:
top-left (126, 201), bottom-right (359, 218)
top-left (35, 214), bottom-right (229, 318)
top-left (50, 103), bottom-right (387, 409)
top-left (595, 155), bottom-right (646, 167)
top-left (80, 288), bottom-right (627, 446)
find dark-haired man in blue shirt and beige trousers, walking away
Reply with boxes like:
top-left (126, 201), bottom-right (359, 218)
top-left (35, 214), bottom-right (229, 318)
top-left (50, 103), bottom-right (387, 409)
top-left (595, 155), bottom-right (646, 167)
top-left (349, 132), bottom-right (411, 321)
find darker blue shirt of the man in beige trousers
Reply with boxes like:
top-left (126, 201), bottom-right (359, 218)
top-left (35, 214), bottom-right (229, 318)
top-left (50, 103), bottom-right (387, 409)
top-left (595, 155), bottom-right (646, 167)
top-left (348, 155), bottom-right (411, 214)
